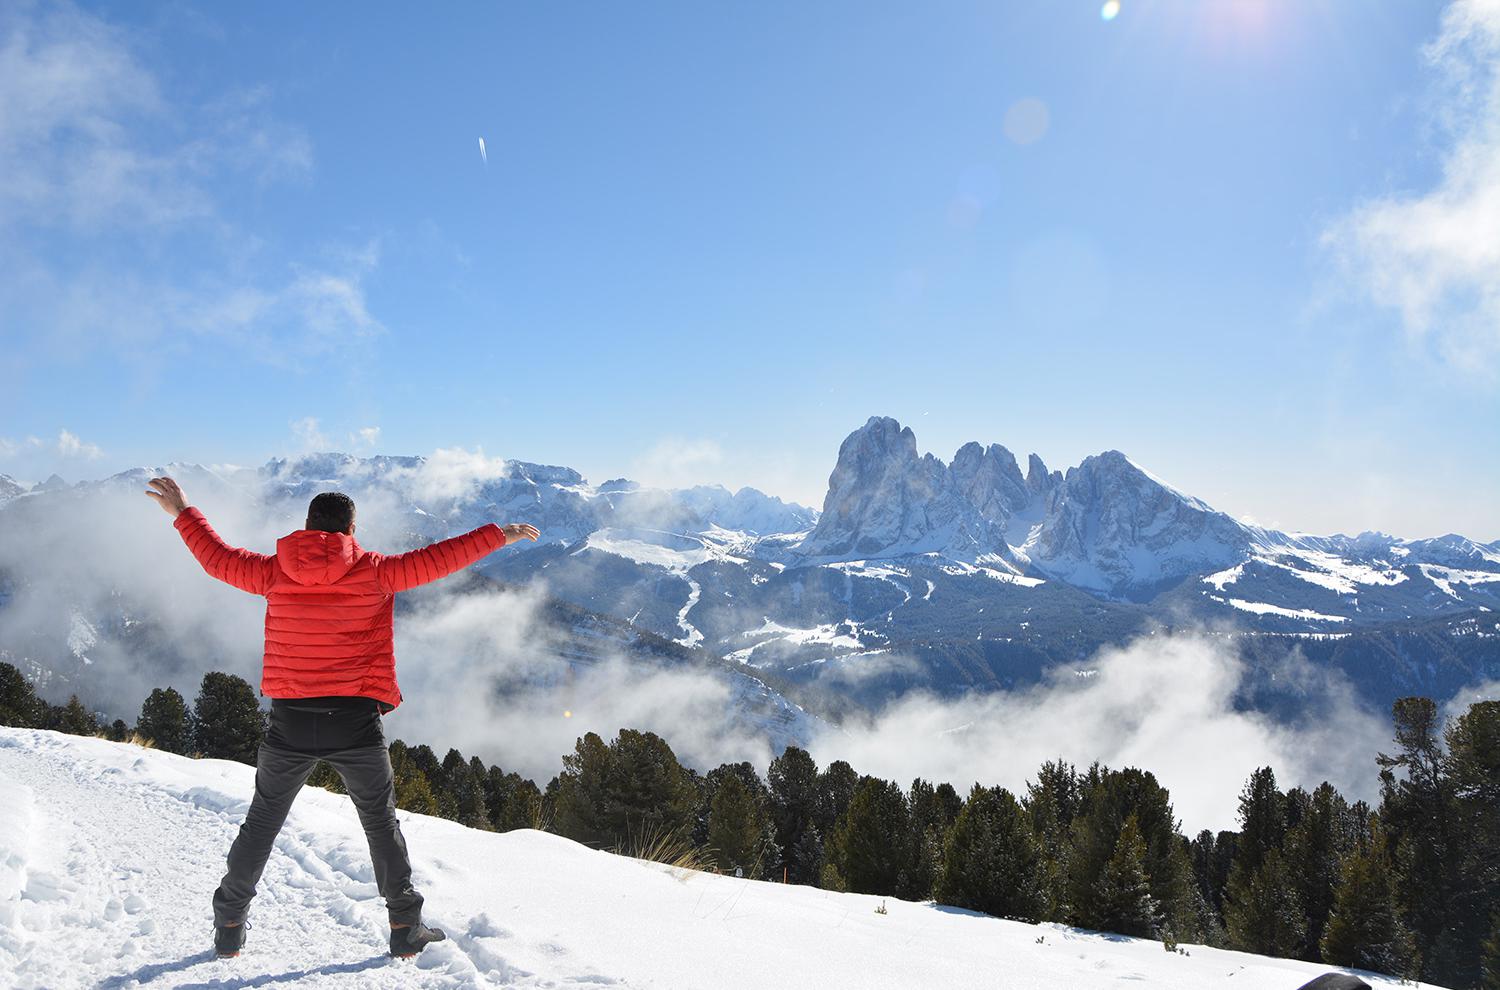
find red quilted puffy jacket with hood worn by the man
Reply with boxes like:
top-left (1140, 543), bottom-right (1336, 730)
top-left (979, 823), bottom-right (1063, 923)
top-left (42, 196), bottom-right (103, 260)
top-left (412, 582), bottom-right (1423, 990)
top-left (174, 507), bottom-right (506, 708)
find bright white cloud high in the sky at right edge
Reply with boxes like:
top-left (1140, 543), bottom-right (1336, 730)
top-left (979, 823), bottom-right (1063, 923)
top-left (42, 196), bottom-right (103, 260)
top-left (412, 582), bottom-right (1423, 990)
top-left (1323, 0), bottom-right (1500, 377)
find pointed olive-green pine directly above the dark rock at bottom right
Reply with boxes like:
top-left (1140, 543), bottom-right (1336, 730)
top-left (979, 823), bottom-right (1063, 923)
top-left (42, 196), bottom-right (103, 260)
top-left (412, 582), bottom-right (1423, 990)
top-left (1320, 822), bottom-right (1416, 977)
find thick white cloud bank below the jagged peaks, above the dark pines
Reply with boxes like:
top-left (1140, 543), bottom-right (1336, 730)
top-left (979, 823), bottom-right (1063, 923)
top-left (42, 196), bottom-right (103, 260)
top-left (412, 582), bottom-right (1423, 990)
top-left (812, 633), bottom-right (1389, 834)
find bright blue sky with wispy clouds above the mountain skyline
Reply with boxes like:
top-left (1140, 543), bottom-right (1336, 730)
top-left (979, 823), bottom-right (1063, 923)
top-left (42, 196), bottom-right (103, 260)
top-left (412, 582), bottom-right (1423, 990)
top-left (0, 0), bottom-right (1500, 540)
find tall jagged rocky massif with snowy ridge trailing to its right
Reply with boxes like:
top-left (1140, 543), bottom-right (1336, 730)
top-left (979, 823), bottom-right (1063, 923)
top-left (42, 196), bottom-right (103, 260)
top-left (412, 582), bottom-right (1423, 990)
top-left (797, 417), bottom-right (1500, 606)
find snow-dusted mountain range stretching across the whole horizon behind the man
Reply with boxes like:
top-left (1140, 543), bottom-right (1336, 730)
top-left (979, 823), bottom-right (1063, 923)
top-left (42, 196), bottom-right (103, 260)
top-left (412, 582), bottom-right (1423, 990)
top-left (0, 417), bottom-right (1500, 723)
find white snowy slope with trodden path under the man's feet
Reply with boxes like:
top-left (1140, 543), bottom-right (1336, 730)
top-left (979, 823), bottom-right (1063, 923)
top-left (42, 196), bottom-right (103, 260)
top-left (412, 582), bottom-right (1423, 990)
top-left (0, 729), bottom-right (1452, 990)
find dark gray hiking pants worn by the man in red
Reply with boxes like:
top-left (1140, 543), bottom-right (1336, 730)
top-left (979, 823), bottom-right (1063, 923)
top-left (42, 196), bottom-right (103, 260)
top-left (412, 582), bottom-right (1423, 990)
top-left (213, 698), bottom-right (422, 926)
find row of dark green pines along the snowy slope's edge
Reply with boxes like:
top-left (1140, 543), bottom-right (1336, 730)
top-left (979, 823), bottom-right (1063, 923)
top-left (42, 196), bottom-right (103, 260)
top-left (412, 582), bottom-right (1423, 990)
top-left (0, 663), bottom-right (1500, 990)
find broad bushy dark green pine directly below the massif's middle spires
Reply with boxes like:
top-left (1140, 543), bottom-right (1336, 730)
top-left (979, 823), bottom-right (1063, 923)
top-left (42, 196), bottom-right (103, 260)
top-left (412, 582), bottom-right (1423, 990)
top-left (935, 785), bottom-right (1046, 921)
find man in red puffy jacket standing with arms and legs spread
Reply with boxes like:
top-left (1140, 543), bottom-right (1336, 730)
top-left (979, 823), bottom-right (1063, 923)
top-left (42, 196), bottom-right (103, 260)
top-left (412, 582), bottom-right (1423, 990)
top-left (146, 477), bottom-right (540, 959)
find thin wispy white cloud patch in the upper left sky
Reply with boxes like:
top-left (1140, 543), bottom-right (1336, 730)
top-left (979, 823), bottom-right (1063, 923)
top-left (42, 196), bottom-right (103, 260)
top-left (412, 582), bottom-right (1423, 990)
top-left (0, 5), bottom-right (383, 378)
